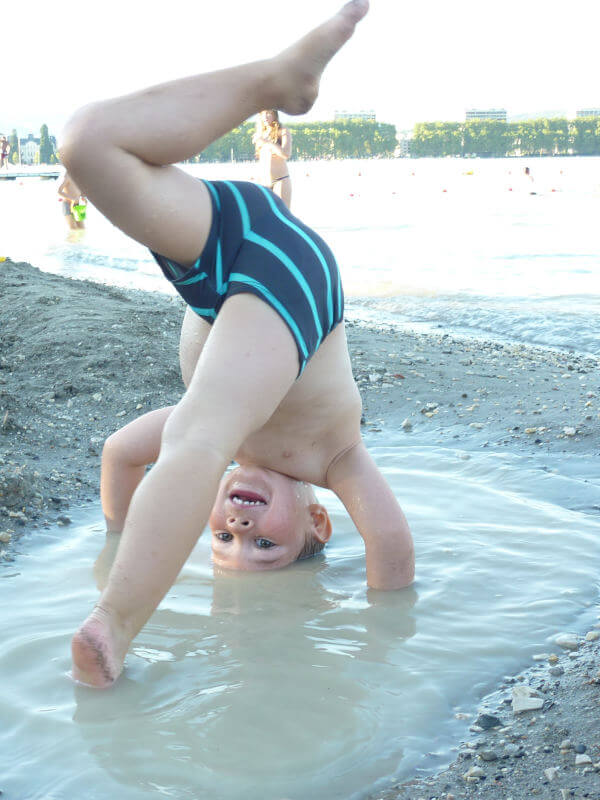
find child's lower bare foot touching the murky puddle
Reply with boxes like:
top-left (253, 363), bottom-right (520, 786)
top-left (71, 606), bottom-right (130, 689)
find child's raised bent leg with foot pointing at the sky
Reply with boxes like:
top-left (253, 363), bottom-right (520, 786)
top-left (60, 0), bottom-right (368, 264)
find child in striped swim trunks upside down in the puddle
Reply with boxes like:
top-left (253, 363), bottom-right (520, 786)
top-left (60, 0), bottom-right (414, 688)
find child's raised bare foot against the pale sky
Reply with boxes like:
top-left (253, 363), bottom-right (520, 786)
top-left (274, 0), bottom-right (369, 114)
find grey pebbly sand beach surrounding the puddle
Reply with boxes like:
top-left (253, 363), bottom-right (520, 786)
top-left (0, 260), bottom-right (600, 800)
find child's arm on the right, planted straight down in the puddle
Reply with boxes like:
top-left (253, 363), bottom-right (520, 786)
top-left (327, 442), bottom-right (415, 589)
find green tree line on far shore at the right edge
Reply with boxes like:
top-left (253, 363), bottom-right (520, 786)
top-left (410, 117), bottom-right (600, 158)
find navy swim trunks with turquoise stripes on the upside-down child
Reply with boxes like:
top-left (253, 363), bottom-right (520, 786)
top-left (150, 181), bottom-right (344, 375)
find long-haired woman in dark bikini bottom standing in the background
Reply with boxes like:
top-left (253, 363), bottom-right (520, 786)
top-left (252, 108), bottom-right (292, 208)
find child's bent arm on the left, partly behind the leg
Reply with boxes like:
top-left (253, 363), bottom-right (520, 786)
top-left (100, 406), bottom-right (175, 533)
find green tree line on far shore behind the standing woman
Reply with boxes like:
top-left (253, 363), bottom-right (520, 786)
top-left (190, 119), bottom-right (398, 162)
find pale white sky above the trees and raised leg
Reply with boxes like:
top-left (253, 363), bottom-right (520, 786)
top-left (0, 0), bottom-right (600, 135)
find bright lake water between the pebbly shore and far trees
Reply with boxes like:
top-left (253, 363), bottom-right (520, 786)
top-left (0, 158), bottom-right (600, 355)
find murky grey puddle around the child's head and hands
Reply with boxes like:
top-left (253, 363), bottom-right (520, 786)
top-left (0, 446), bottom-right (600, 800)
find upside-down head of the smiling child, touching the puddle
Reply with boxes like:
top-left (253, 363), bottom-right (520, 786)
top-left (209, 467), bottom-right (331, 571)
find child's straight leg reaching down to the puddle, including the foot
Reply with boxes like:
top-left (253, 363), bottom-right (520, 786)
top-left (72, 294), bottom-right (298, 687)
